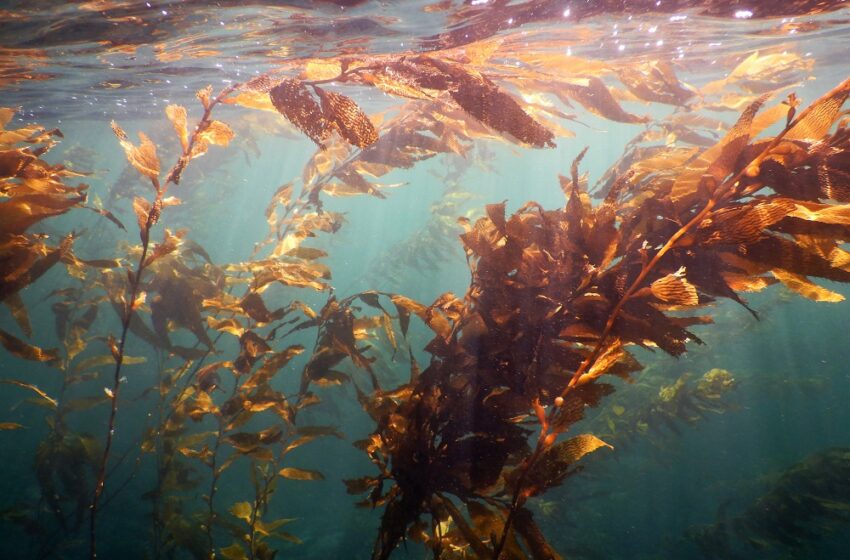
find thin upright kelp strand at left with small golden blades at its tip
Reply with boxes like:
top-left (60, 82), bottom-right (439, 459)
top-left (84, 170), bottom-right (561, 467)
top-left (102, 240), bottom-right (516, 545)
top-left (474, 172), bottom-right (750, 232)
top-left (89, 81), bottom-right (236, 559)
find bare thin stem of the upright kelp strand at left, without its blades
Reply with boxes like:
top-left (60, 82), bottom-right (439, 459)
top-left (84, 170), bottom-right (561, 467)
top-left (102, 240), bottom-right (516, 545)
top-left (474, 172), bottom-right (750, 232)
top-left (89, 84), bottom-right (239, 560)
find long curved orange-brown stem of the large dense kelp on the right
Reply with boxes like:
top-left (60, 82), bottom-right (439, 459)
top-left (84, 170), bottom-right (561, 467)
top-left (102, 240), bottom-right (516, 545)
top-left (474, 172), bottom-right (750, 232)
top-left (493, 79), bottom-right (850, 560)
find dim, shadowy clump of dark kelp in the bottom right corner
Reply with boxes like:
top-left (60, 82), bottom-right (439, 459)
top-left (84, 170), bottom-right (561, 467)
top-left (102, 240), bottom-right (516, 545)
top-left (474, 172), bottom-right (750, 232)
top-left (689, 448), bottom-right (850, 560)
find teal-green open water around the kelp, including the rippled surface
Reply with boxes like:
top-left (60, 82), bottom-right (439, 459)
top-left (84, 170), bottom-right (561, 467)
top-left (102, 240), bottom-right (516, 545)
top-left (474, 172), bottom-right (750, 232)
top-left (0, 1), bottom-right (850, 559)
